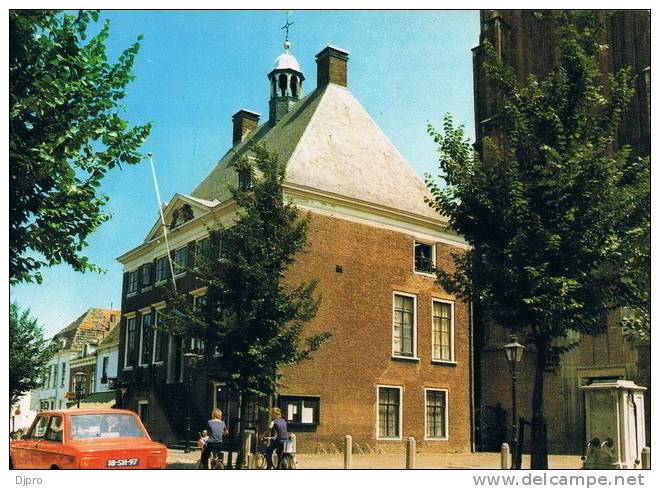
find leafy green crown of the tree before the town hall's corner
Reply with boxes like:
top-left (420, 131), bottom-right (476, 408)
top-left (166, 146), bottom-right (330, 399)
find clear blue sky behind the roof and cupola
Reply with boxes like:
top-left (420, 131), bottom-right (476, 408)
top-left (10, 10), bottom-right (479, 336)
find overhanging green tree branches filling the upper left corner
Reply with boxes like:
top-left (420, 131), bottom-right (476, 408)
top-left (9, 10), bottom-right (151, 284)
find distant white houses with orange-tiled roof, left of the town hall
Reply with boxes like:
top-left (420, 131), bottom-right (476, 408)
top-left (32, 307), bottom-right (120, 411)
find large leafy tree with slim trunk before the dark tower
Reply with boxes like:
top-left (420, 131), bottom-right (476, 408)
top-left (427, 11), bottom-right (649, 468)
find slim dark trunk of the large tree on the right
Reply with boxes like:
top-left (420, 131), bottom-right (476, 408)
top-left (520, 337), bottom-right (550, 469)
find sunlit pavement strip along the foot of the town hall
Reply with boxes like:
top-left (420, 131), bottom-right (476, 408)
top-left (167, 450), bottom-right (582, 469)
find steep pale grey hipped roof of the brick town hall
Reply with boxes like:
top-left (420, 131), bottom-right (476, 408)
top-left (191, 84), bottom-right (440, 220)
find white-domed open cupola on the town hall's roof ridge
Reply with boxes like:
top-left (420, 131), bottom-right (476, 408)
top-left (268, 36), bottom-right (305, 126)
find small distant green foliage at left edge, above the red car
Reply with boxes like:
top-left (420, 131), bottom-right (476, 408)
top-left (9, 302), bottom-right (53, 404)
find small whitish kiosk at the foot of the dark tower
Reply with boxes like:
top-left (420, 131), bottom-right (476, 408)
top-left (582, 379), bottom-right (646, 469)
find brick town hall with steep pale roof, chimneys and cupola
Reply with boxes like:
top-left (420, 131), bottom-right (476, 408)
top-left (118, 40), bottom-right (471, 452)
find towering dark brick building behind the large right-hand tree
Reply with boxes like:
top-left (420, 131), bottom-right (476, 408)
top-left (473, 10), bottom-right (651, 453)
